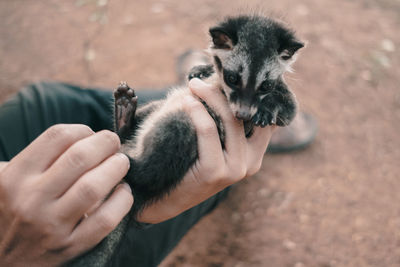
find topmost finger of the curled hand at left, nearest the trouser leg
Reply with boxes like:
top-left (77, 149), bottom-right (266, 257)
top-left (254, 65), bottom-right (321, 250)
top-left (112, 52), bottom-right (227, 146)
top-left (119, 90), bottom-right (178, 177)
top-left (10, 124), bottom-right (94, 177)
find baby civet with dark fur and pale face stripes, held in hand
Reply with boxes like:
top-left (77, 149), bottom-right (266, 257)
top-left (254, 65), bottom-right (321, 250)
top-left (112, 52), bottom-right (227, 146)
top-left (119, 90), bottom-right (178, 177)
top-left (114, 15), bottom-right (304, 221)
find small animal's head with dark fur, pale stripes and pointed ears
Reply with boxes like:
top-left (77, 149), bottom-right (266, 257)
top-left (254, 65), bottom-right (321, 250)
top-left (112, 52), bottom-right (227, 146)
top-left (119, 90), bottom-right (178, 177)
top-left (210, 14), bottom-right (303, 121)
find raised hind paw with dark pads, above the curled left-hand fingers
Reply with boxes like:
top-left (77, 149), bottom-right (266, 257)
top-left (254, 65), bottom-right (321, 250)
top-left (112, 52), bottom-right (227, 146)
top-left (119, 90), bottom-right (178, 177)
top-left (114, 82), bottom-right (137, 143)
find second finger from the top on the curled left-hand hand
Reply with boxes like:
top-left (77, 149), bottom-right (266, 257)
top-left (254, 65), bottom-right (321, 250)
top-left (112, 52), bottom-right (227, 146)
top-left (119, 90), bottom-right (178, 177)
top-left (43, 130), bottom-right (120, 197)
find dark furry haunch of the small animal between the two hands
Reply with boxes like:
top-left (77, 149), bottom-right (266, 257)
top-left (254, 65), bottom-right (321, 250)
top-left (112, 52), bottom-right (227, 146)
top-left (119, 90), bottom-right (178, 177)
top-left (125, 112), bottom-right (197, 218)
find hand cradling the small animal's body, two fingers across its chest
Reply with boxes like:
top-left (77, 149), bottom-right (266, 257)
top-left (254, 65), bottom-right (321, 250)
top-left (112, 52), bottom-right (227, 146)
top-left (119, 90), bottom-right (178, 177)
top-left (138, 79), bottom-right (274, 223)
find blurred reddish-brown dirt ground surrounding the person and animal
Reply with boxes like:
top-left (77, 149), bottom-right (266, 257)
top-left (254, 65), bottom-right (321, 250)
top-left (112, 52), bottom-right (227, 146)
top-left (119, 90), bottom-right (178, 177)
top-left (0, 0), bottom-right (400, 267)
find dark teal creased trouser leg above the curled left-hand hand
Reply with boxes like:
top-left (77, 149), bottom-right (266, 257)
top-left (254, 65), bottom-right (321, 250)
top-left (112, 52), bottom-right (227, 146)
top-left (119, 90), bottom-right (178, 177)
top-left (0, 82), bottom-right (113, 161)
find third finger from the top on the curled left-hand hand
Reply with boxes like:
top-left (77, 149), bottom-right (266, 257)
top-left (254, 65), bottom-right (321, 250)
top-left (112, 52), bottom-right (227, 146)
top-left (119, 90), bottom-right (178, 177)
top-left (58, 153), bottom-right (129, 222)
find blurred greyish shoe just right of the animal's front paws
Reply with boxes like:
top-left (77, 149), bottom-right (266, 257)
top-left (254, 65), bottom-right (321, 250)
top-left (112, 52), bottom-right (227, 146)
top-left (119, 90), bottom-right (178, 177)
top-left (267, 112), bottom-right (318, 153)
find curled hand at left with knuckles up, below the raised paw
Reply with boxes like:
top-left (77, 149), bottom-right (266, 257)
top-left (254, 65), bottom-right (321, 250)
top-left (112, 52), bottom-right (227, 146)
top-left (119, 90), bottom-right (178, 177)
top-left (0, 125), bottom-right (133, 266)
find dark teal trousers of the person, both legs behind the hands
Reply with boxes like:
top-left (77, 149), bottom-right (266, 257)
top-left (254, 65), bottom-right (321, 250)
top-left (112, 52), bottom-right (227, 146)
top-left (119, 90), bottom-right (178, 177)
top-left (0, 82), bottom-right (228, 266)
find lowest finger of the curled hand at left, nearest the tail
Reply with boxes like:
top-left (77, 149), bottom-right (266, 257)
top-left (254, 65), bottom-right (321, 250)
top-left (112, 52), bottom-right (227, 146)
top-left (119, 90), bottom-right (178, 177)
top-left (69, 183), bottom-right (133, 255)
